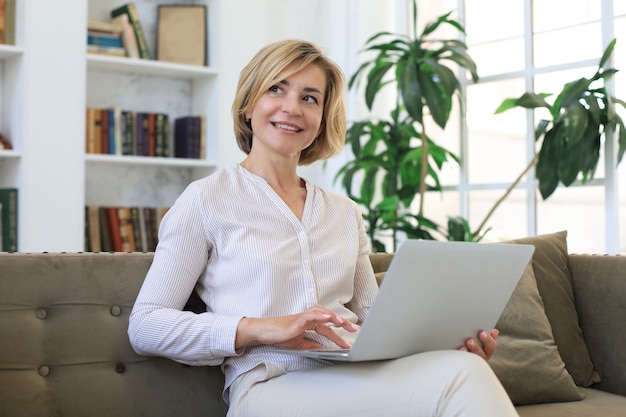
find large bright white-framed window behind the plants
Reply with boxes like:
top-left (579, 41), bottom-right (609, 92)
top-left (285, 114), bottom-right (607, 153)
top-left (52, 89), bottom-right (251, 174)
top-left (416, 0), bottom-right (626, 253)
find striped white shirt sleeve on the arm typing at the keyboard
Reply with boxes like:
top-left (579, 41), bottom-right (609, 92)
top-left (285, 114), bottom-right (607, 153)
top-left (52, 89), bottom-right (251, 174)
top-left (128, 184), bottom-right (241, 366)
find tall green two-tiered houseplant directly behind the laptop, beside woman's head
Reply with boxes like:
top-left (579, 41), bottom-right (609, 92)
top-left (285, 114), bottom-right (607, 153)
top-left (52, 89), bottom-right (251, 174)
top-left (335, 0), bottom-right (478, 251)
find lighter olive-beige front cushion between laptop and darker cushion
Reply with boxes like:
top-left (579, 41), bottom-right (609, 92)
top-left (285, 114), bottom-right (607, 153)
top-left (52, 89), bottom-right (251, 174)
top-left (489, 263), bottom-right (582, 405)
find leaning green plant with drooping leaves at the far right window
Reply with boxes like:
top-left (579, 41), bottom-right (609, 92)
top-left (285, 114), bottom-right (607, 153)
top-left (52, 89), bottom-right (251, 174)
top-left (474, 39), bottom-right (626, 236)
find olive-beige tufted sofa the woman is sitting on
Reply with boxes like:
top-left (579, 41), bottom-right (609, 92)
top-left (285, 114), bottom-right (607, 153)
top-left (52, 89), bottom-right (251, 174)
top-left (0, 239), bottom-right (626, 417)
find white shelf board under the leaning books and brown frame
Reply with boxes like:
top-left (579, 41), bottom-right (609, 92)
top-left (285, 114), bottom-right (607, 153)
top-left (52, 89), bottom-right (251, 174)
top-left (87, 54), bottom-right (217, 79)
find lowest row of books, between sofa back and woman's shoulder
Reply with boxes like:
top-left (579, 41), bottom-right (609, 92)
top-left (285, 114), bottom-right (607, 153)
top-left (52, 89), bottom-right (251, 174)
top-left (85, 205), bottom-right (168, 252)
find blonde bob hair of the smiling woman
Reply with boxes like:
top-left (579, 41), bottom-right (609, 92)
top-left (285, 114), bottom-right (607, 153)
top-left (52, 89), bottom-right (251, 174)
top-left (232, 40), bottom-right (346, 165)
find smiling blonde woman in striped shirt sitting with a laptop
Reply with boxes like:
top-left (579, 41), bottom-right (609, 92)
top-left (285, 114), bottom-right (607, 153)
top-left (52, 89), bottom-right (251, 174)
top-left (129, 40), bottom-right (517, 417)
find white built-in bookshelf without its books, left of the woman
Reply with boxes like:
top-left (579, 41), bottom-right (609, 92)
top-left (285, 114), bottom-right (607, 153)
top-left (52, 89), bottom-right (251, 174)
top-left (0, 0), bottom-right (221, 252)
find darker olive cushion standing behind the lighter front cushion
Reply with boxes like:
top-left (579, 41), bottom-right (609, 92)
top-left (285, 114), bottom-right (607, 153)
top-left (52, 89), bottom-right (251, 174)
top-left (509, 231), bottom-right (600, 387)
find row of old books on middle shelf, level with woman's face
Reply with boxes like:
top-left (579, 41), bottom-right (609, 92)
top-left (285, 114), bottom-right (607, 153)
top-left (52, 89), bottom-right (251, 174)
top-left (85, 106), bottom-right (206, 159)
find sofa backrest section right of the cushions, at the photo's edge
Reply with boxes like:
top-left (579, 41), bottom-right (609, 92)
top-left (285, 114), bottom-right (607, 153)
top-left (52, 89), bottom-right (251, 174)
top-left (569, 255), bottom-right (626, 395)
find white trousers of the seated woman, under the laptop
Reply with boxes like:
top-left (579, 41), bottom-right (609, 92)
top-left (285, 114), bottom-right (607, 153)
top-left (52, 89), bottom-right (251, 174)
top-left (228, 351), bottom-right (518, 417)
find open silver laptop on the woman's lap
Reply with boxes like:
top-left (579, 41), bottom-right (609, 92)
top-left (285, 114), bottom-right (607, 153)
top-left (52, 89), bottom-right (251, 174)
top-left (274, 240), bottom-right (534, 361)
